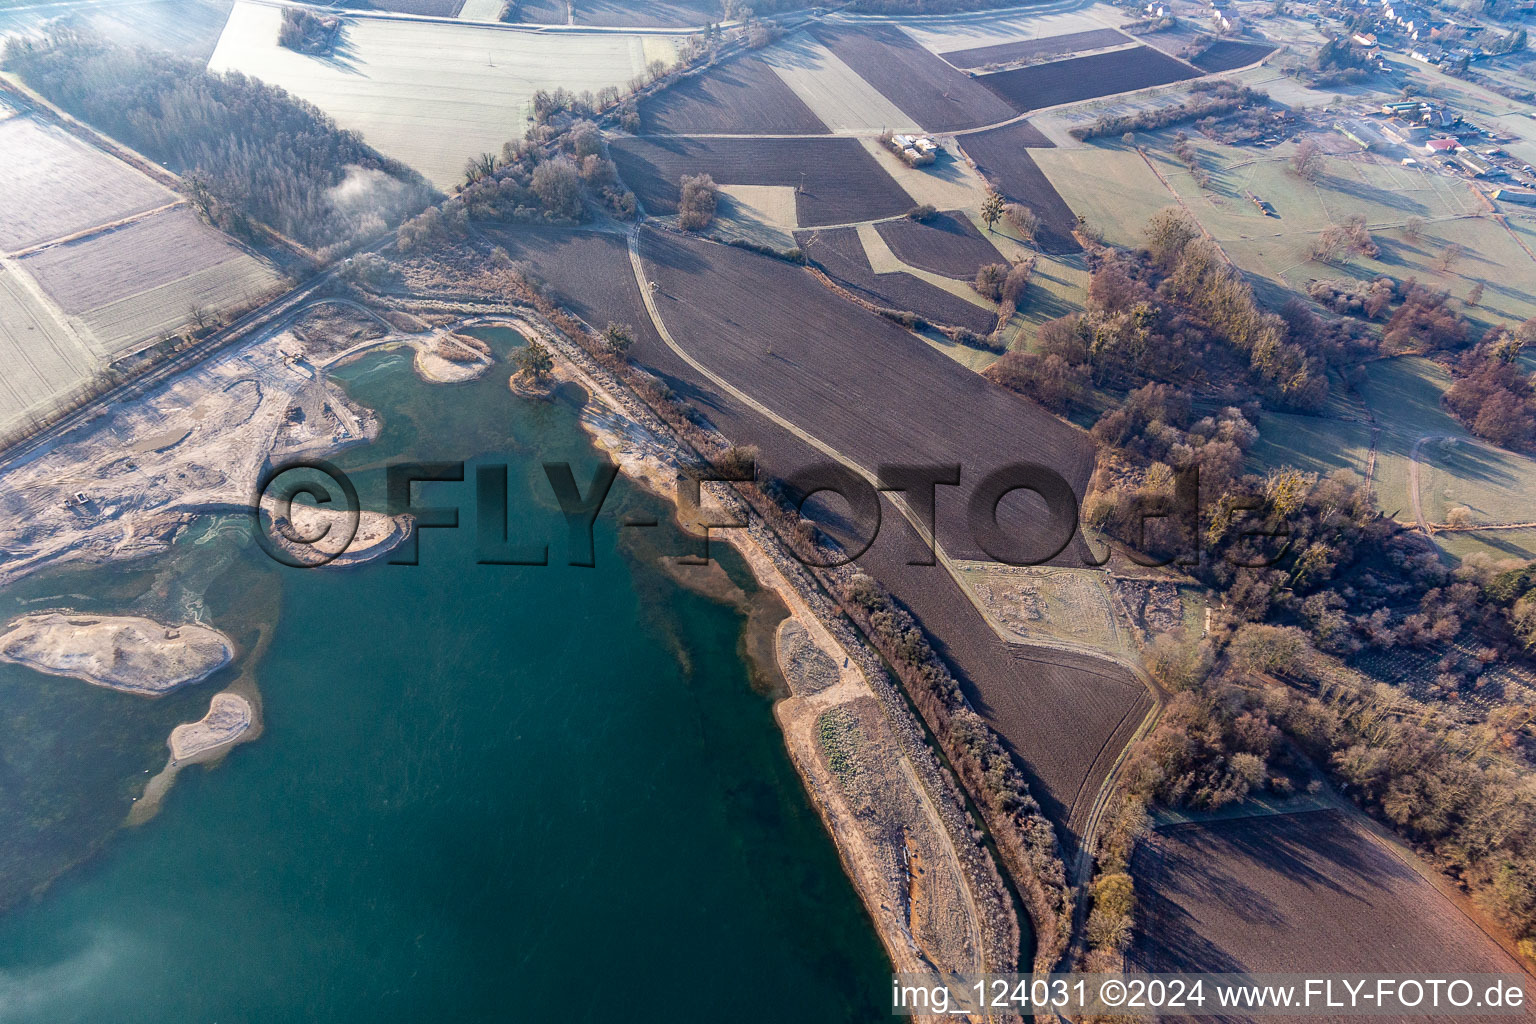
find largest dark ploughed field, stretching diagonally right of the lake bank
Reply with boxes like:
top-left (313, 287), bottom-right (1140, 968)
top-left (617, 232), bottom-right (1149, 847)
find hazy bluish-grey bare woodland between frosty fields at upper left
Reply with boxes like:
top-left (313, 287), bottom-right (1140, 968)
top-left (5, 29), bottom-right (433, 249)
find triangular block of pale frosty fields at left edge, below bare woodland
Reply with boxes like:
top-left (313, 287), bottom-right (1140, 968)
top-left (0, 109), bottom-right (280, 431)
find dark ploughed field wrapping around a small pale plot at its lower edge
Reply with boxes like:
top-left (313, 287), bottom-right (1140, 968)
top-left (611, 137), bottom-right (912, 227)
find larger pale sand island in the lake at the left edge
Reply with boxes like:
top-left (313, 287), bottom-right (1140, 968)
top-left (0, 611), bottom-right (235, 697)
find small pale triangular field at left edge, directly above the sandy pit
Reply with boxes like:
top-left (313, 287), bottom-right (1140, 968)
top-left (0, 261), bottom-right (97, 431)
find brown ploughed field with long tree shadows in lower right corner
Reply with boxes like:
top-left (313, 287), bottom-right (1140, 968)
top-left (1129, 811), bottom-right (1521, 973)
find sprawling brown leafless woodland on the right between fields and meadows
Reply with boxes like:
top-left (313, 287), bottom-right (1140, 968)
top-left (991, 210), bottom-right (1536, 969)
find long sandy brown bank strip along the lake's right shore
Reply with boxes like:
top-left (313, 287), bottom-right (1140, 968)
top-left (497, 308), bottom-right (1018, 1013)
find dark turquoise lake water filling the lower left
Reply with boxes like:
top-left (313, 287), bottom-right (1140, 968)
top-left (0, 332), bottom-right (889, 1024)
